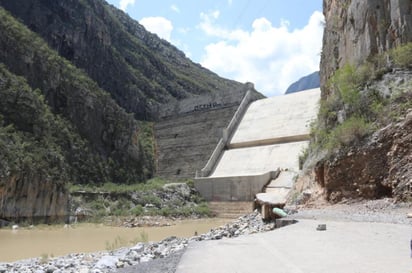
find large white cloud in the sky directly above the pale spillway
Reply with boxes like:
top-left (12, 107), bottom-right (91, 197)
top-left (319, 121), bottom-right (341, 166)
top-left (199, 11), bottom-right (323, 96)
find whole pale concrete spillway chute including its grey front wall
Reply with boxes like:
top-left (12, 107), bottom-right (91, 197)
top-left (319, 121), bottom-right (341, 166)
top-left (195, 89), bottom-right (320, 201)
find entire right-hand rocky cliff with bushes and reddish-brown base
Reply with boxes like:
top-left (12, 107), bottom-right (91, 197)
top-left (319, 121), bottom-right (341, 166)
top-left (301, 0), bottom-right (412, 202)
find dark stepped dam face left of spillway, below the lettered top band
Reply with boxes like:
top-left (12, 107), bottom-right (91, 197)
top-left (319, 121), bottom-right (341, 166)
top-left (155, 106), bottom-right (236, 179)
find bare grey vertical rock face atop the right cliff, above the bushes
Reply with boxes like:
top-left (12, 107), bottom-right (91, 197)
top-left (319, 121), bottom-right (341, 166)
top-left (320, 0), bottom-right (412, 86)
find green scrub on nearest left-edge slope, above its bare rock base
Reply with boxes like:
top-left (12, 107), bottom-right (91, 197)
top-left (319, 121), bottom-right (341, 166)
top-left (0, 64), bottom-right (71, 183)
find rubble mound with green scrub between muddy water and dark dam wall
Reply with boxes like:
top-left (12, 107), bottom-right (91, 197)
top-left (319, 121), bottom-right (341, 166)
top-left (70, 183), bottom-right (209, 221)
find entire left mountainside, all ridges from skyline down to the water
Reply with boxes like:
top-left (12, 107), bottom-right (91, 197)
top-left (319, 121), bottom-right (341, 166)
top-left (0, 0), bottom-right (262, 221)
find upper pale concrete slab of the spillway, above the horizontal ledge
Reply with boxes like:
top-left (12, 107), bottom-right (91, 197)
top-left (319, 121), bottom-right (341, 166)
top-left (230, 88), bottom-right (320, 147)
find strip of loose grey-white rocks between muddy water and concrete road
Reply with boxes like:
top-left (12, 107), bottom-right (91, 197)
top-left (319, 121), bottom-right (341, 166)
top-left (0, 212), bottom-right (275, 273)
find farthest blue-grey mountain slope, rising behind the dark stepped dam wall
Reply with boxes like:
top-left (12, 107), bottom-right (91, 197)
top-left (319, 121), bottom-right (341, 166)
top-left (0, 0), bottom-right (242, 120)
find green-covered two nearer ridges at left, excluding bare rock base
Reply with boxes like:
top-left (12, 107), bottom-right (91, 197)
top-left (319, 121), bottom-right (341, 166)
top-left (0, 8), bottom-right (154, 184)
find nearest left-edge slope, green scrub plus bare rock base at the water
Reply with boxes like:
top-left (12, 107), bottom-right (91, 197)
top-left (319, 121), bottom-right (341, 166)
top-left (0, 65), bottom-right (70, 220)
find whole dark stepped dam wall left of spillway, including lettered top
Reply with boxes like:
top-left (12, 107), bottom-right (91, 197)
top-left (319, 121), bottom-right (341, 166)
top-left (154, 83), bottom-right (263, 180)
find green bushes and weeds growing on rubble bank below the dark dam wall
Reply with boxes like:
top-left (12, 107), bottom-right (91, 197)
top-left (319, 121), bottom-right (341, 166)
top-left (69, 178), bottom-right (211, 221)
